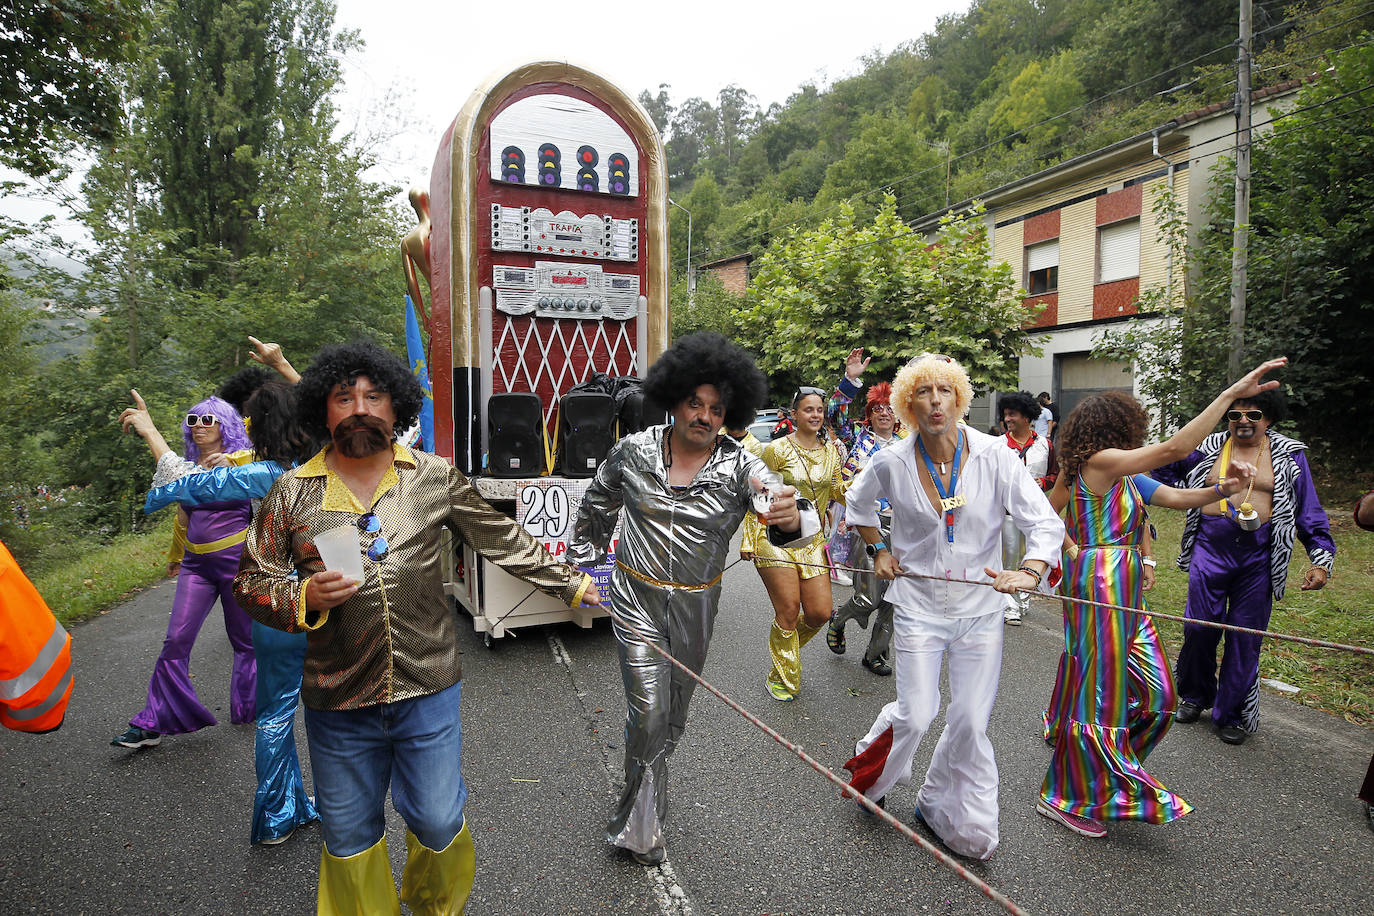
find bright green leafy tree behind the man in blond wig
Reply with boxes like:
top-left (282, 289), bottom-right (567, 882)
top-left (735, 195), bottom-right (1036, 389)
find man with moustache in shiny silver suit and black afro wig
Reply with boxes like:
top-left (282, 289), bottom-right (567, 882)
top-left (567, 332), bottom-right (820, 865)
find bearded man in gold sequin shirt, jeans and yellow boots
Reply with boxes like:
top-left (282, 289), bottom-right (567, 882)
top-left (234, 343), bottom-right (600, 913)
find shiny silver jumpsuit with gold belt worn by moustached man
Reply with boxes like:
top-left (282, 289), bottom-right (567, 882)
top-left (567, 426), bottom-right (819, 854)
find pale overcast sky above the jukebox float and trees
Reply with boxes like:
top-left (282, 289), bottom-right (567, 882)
top-left (337, 0), bottom-right (971, 193)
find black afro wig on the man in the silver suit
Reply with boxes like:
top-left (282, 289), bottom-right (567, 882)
top-left (644, 331), bottom-right (768, 430)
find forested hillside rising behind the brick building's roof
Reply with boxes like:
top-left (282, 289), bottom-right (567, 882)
top-left (651, 0), bottom-right (1374, 271)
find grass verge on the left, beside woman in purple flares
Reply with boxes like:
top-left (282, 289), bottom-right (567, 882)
top-left (33, 512), bottom-right (174, 626)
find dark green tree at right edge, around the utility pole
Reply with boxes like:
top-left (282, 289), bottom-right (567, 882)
top-left (1184, 45), bottom-right (1374, 455)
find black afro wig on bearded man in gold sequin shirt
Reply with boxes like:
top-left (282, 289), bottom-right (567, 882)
top-left (295, 341), bottom-right (425, 442)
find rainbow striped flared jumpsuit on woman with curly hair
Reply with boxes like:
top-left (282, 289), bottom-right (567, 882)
top-left (1040, 478), bottom-right (1193, 824)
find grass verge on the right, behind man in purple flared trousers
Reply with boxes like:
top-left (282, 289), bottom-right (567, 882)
top-left (1146, 499), bottom-right (1374, 728)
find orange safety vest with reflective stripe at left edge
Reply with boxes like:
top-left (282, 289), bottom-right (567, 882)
top-left (0, 542), bottom-right (71, 732)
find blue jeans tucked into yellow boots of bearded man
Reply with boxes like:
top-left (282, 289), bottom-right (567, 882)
top-left (305, 683), bottom-right (467, 858)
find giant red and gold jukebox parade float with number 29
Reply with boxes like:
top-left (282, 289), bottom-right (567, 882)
top-left (401, 62), bottom-right (668, 645)
